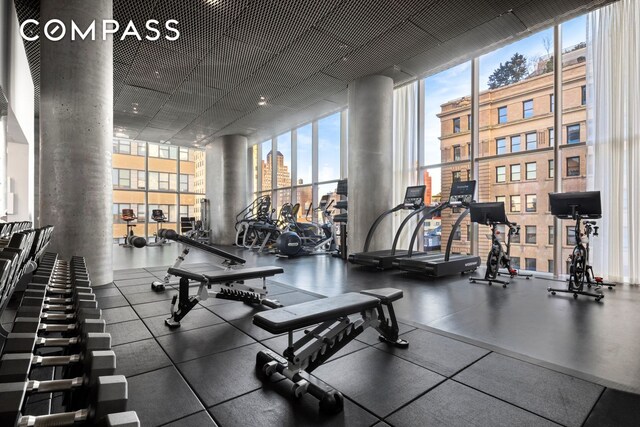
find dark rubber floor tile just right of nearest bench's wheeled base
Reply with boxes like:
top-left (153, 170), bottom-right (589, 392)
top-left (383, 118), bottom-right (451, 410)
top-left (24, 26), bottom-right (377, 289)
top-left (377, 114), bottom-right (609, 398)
top-left (313, 347), bottom-right (445, 417)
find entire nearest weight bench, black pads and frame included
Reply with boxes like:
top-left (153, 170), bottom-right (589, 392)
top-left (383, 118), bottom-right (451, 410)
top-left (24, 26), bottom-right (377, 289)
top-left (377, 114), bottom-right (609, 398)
top-left (253, 288), bottom-right (409, 413)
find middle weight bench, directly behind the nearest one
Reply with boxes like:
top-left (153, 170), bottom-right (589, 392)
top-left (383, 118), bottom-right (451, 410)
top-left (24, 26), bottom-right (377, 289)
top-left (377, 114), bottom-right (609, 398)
top-left (164, 267), bottom-right (284, 328)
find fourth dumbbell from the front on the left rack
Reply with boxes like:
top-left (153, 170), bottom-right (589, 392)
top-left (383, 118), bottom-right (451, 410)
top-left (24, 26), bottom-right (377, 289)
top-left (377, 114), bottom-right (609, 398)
top-left (4, 332), bottom-right (111, 354)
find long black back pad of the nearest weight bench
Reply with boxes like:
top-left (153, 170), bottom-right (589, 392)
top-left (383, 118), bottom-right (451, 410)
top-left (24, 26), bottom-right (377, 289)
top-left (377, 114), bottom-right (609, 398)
top-left (253, 292), bottom-right (380, 334)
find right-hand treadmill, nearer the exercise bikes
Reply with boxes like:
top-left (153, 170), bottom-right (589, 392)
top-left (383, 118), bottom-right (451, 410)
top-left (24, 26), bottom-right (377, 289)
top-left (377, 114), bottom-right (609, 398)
top-left (393, 181), bottom-right (480, 277)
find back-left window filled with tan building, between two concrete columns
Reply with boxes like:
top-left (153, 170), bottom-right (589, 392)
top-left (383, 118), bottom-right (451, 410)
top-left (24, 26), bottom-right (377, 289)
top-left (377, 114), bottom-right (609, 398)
top-left (112, 139), bottom-right (206, 242)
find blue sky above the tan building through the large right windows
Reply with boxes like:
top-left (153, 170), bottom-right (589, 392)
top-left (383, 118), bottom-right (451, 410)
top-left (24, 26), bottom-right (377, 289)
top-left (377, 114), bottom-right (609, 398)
top-left (424, 15), bottom-right (586, 194)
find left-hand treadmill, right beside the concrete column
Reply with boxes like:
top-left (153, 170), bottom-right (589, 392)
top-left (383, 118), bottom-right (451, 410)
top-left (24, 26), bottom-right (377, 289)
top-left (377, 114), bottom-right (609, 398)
top-left (349, 185), bottom-right (427, 270)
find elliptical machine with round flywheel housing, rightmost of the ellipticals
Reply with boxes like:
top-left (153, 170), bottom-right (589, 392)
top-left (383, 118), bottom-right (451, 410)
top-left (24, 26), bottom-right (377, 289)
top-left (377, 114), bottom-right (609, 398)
top-left (276, 194), bottom-right (336, 258)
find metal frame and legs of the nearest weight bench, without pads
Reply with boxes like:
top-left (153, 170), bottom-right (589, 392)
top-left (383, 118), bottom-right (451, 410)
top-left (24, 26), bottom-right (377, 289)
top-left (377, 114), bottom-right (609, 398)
top-left (254, 290), bottom-right (409, 413)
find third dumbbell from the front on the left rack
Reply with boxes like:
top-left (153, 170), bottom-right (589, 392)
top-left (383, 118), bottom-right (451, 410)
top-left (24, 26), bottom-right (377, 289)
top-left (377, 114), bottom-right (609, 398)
top-left (0, 348), bottom-right (116, 384)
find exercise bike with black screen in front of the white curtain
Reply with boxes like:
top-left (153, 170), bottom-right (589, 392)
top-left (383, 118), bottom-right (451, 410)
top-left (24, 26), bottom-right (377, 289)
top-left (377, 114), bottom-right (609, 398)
top-left (547, 191), bottom-right (615, 301)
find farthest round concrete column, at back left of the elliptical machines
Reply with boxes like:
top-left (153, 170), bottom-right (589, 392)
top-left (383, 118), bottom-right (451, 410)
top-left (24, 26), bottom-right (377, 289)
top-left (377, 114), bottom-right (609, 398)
top-left (206, 135), bottom-right (249, 245)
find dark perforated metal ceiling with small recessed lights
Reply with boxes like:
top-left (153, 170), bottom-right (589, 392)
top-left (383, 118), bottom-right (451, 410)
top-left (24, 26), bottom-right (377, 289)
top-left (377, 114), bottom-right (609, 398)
top-left (14, 0), bottom-right (612, 145)
